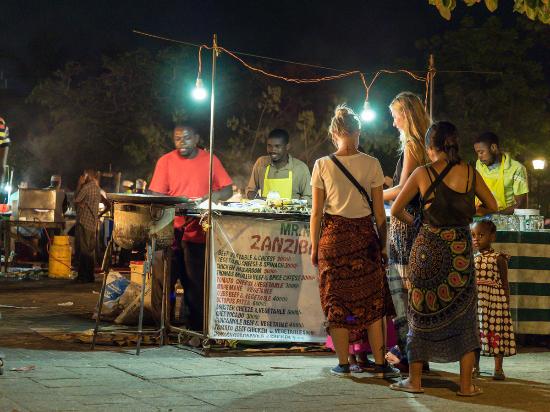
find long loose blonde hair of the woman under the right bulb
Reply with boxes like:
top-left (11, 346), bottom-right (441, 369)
top-left (390, 92), bottom-right (432, 166)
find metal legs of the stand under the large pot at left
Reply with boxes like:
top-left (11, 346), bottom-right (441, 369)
top-left (91, 235), bottom-right (168, 356)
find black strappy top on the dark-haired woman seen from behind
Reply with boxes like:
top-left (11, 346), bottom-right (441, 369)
top-left (424, 165), bottom-right (476, 227)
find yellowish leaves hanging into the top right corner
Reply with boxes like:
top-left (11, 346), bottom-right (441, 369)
top-left (428, 0), bottom-right (550, 24)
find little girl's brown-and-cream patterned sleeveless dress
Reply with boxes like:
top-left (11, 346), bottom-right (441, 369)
top-left (474, 249), bottom-right (516, 356)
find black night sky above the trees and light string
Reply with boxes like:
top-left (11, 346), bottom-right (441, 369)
top-left (0, 0), bottom-right (512, 87)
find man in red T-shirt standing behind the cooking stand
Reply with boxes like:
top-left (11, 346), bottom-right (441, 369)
top-left (149, 125), bottom-right (233, 331)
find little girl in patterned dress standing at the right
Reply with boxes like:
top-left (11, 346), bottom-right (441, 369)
top-left (472, 220), bottom-right (516, 380)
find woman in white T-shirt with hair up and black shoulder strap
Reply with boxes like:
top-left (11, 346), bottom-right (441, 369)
top-left (310, 105), bottom-right (399, 378)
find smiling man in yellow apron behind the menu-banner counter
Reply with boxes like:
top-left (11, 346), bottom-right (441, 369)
top-left (246, 129), bottom-right (311, 204)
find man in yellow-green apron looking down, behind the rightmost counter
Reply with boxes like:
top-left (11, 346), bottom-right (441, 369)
top-left (474, 132), bottom-right (529, 214)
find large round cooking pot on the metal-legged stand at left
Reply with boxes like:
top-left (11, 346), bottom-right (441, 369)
top-left (113, 202), bottom-right (176, 250)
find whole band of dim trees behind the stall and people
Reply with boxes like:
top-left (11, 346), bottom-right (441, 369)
top-left (23, 16), bottom-right (550, 196)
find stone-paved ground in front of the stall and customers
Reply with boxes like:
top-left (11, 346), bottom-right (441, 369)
top-left (0, 281), bottom-right (550, 411)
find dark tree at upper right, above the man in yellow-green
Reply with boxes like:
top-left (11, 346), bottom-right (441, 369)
top-left (418, 16), bottom-right (550, 160)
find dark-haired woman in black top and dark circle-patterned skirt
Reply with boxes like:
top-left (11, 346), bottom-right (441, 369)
top-left (390, 122), bottom-right (497, 396)
